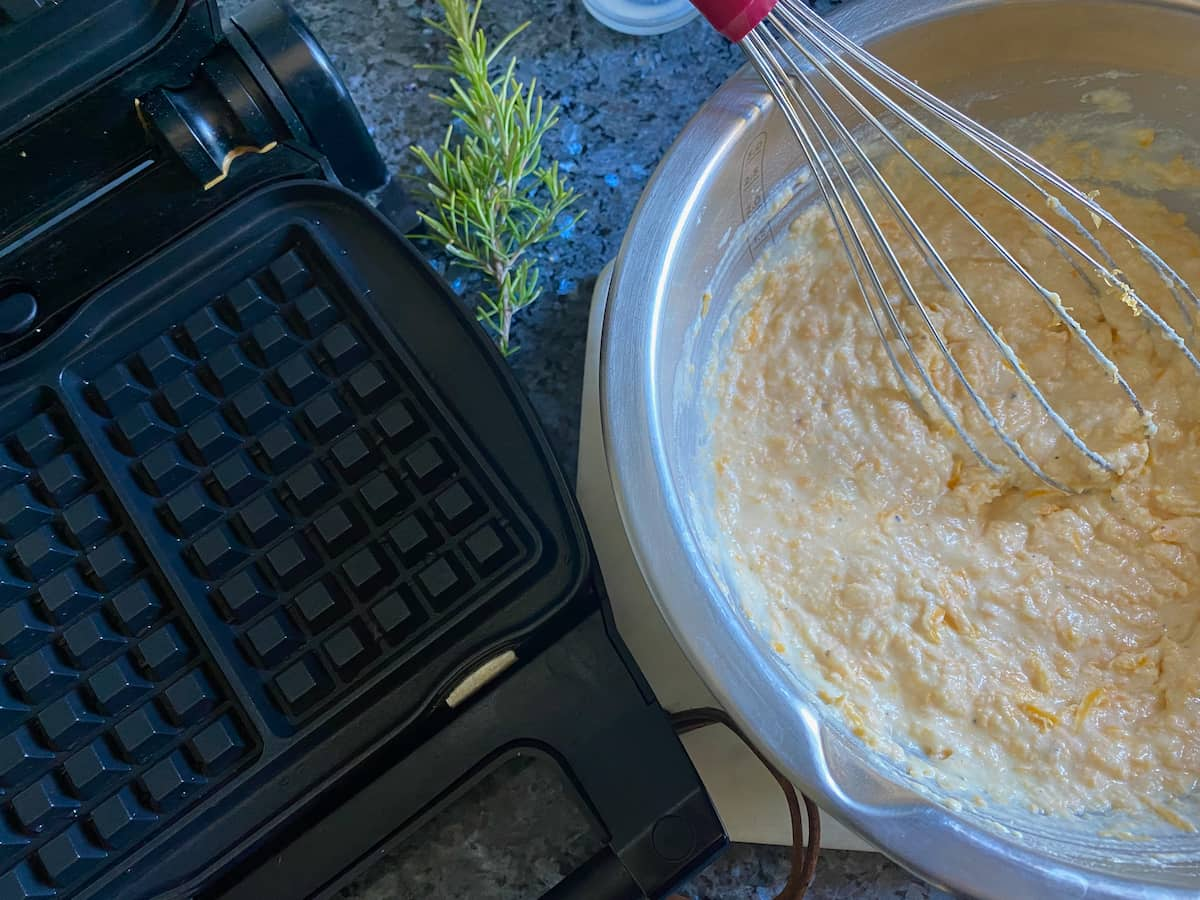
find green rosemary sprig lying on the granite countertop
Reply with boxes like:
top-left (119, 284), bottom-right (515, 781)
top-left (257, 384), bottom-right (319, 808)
top-left (412, 0), bottom-right (582, 356)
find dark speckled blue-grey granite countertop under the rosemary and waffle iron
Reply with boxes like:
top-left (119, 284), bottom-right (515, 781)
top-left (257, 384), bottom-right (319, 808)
top-left (250, 0), bottom-right (940, 900)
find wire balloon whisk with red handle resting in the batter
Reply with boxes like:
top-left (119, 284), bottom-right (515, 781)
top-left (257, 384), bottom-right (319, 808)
top-left (694, 0), bottom-right (1200, 493)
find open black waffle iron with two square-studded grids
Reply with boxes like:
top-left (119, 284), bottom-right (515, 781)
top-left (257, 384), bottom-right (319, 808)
top-left (0, 0), bottom-right (725, 900)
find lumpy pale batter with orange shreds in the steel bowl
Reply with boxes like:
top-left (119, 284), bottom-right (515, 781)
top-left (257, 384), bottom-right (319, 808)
top-left (709, 131), bottom-right (1200, 830)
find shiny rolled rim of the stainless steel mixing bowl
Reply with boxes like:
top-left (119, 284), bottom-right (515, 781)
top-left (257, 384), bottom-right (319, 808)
top-left (600, 0), bottom-right (1200, 899)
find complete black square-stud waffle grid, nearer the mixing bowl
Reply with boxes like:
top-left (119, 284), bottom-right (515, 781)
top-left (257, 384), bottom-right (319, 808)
top-left (77, 232), bottom-right (535, 733)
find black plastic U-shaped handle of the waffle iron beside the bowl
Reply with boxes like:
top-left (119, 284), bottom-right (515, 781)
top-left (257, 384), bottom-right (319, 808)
top-left (204, 610), bottom-right (726, 900)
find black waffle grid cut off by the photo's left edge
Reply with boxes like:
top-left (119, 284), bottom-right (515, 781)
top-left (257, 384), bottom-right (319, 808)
top-left (0, 390), bottom-right (259, 900)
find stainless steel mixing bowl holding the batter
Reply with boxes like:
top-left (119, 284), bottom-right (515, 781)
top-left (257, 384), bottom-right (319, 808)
top-left (601, 0), bottom-right (1200, 898)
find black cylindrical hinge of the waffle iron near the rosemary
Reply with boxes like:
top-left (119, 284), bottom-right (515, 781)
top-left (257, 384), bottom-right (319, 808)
top-left (136, 0), bottom-right (388, 193)
